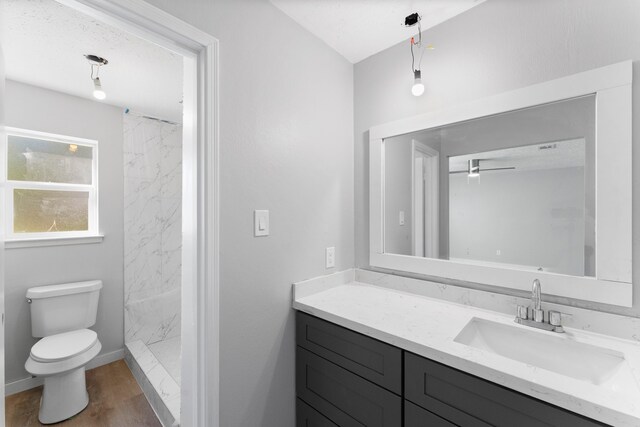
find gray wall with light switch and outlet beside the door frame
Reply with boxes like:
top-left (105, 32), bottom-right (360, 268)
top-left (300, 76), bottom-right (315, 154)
top-left (129, 0), bottom-right (354, 427)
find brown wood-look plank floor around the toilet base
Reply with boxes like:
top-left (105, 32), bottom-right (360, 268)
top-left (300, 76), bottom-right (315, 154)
top-left (5, 360), bottom-right (161, 427)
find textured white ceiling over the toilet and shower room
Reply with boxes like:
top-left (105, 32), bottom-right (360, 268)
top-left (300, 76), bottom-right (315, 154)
top-left (0, 0), bottom-right (182, 121)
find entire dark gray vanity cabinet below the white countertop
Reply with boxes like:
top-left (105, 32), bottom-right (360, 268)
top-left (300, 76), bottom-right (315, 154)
top-left (296, 312), bottom-right (605, 427)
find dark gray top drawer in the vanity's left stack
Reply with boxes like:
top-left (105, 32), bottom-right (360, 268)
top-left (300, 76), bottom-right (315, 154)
top-left (296, 311), bottom-right (402, 395)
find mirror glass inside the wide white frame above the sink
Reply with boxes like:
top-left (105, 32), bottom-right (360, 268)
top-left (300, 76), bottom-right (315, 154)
top-left (383, 95), bottom-right (596, 277)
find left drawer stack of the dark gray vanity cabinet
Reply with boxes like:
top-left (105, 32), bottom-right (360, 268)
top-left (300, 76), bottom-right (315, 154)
top-left (296, 312), bottom-right (402, 427)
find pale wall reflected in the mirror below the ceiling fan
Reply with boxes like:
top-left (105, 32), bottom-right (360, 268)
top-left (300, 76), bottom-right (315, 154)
top-left (449, 167), bottom-right (585, 276)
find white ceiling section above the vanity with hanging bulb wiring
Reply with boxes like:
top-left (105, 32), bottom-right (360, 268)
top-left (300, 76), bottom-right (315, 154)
top-left (271, 0), bottom-right (485, 63)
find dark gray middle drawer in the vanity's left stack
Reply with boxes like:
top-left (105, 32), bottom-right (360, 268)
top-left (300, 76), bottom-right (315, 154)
top-left (296, 347), bottom-right (402, 427)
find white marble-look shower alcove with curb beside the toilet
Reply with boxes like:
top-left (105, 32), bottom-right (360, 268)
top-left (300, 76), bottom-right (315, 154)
top-left (123, 114), bottom-right (182, 425)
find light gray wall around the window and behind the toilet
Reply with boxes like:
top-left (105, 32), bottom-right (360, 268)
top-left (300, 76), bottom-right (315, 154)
top-left (4, 81), bottom-right (124, 383)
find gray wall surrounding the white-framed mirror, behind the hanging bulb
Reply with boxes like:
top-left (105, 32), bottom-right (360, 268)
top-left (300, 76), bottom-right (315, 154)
top-left (354, 0), bottom-right (640, 316)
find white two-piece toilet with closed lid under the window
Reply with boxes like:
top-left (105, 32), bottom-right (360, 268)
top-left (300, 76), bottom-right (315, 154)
top-left (25, 280), bottom-right (102, 424)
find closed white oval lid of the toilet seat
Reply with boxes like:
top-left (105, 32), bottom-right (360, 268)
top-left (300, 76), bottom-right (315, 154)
top-left (31, 329), bottom-right (98, 362)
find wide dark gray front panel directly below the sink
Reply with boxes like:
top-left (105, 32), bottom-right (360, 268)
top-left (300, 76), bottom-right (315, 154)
top-left (405, 352), bottom-right (604, 427)
